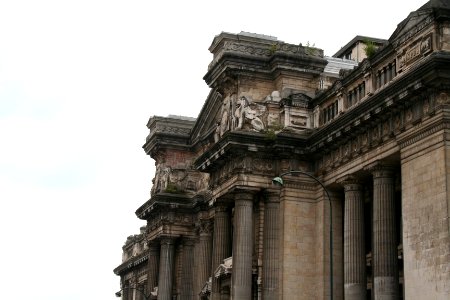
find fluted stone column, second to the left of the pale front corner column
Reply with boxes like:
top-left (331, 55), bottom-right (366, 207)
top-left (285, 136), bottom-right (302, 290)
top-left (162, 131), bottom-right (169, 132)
top-left (194, 220), bottom-right (212, 299)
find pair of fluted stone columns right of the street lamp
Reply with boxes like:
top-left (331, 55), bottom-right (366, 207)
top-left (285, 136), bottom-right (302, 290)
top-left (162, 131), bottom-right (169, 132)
top-left (342, 165), bottom-right (399, 300)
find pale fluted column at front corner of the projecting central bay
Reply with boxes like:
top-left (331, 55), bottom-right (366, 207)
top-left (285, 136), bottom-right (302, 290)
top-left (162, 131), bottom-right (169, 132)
top-left (231, 190), bottom-right (253, 299)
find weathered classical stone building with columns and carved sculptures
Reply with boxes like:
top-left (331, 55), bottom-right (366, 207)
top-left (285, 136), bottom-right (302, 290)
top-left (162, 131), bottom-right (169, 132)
top-left (114, 0), bottom-right (450, 300)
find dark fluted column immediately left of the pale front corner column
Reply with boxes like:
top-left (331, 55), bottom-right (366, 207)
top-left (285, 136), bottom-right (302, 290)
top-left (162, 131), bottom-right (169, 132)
top-left (211, 202), bottom-right (231, 300)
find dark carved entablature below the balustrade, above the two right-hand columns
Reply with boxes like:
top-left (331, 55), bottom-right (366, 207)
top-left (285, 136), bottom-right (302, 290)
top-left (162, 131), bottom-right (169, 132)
top-left (308, 52), bottom-right (450, 168)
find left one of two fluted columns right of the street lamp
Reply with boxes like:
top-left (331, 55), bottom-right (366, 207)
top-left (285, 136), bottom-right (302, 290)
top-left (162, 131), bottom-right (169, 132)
top-left (343, 178), bottom-right (367, 300)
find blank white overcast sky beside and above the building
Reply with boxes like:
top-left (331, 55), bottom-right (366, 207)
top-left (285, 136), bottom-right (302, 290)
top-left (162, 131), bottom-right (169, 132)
top-left (0, 0), bottom-right (425, 300)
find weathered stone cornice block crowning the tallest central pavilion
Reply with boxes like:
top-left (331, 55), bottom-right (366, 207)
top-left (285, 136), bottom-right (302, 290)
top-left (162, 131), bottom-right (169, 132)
top-left (203, 32), bottom-right (327, 88)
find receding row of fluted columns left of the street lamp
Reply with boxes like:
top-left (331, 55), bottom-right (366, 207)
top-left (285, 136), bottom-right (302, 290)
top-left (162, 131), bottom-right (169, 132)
top-left (147, 190), bottom-right (280, 300)
